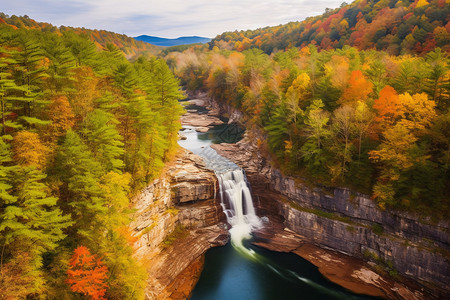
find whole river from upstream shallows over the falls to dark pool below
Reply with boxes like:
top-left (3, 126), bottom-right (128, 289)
top-left (179, 108), bottom-right (374, 300)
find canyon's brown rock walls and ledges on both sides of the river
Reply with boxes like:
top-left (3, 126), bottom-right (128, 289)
top-left (132, 97), bottom-right (450, 299)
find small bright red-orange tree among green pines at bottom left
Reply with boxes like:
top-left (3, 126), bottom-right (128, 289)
top-left (67, 246), bottom-right (108, 300)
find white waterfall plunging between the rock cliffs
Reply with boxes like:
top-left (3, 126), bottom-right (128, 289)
top-left (217, 166), bottom-right (261, 249)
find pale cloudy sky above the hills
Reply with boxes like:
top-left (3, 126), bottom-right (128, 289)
top-left (0, 0), bottom-right (343, 38)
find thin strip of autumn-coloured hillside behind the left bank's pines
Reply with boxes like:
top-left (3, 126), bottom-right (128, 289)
top-left (0, 13), bottom-right (161, 59)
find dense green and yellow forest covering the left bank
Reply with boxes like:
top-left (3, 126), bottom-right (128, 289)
top-left (0, 15), bottom-right (183, 299)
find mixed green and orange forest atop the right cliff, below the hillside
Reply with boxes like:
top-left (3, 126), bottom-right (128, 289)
top-left (166, 8), bottom-right (450, 214)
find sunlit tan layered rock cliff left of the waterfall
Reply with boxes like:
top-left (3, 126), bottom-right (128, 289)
top-left (131, 150), bottom-right (228, 299)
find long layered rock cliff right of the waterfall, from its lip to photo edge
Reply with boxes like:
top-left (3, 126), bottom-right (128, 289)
top-left (214, 136), bottom-right (450, 297)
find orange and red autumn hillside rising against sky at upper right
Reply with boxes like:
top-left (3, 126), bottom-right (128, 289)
top-left (210, 0), bottom-right (450, 55)
